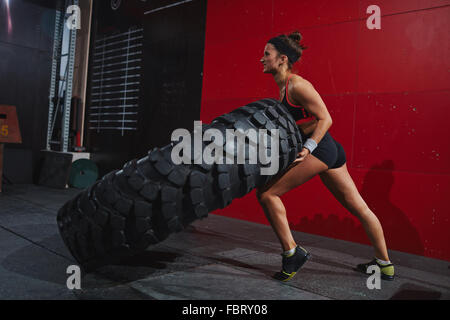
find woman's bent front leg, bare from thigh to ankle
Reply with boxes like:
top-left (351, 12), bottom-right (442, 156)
top-left (256, 154), bottom-right (328, 251)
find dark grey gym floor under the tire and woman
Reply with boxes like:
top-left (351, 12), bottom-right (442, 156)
top-left (0, 185), bottom-right (450, 300)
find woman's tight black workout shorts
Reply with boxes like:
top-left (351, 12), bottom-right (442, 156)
top-left (302, 131), bottom-right (347, 169)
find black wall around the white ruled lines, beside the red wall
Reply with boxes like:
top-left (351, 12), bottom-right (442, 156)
top-left (85, 0), bottom-right (206, 175)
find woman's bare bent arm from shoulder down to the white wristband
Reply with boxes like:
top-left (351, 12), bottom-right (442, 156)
top-left (290, 78), bottom-right (333, 156)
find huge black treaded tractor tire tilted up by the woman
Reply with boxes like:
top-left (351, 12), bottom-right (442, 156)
top-left (57, 99), bottom-right (302, 271)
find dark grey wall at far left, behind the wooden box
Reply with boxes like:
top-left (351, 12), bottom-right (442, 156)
top-left (0, 0), bottom-right (55, 183)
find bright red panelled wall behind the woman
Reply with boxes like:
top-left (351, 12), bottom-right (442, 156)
top-left (201, 0), bottom-right (450, 261)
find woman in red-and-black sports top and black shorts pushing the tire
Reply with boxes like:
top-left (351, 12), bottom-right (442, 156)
top-left (256, 31), bottom-right (394, 281)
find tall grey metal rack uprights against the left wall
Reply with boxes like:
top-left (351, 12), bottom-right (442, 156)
top-left (47, 0), bottom-right (78, 152)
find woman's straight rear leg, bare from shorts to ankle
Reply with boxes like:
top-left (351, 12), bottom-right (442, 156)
top-left (320, 164), bottom-right (389, 261)
